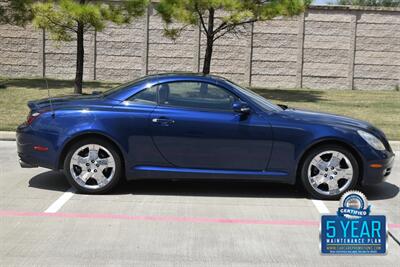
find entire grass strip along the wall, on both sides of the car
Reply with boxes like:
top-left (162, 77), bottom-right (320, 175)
top-left (0, 79), bottom-right (400, 140)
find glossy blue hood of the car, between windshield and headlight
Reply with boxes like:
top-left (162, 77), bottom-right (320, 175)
top-left (283, 109), bottom-right (385, 137)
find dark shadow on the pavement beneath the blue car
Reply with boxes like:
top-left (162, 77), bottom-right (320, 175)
top-left (29, 171), bottom-right (399, 200)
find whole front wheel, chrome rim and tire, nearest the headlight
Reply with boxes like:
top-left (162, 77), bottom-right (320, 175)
top-left (301, 145), bottom-right (359, 199)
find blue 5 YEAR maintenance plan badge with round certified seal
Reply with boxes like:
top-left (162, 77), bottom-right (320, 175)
top-left (320, 191), bottom-right (387, 254)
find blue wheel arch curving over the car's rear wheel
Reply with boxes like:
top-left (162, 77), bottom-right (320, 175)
top-left (57, 132), bottom-right (125, 170)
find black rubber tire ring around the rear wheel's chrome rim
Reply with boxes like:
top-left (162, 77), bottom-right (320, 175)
top-left (63, 138), bottom-right (123, 194)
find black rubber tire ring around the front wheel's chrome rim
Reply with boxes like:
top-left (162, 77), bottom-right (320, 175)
top-left (300, 145), bottom-right (360, 200)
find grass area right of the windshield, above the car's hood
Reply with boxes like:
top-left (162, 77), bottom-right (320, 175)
top-left (253, 88), bottom-right (400, 140)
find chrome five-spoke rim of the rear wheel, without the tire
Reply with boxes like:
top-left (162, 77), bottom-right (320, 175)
top-left (70, 144), bottom-right (115, 189)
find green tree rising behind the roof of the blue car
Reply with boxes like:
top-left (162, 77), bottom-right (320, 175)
top-left (156, 0), bottom-right (311, 74)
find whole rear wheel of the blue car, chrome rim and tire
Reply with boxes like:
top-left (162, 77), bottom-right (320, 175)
top-left (64, 138), bottom-right (122, 193)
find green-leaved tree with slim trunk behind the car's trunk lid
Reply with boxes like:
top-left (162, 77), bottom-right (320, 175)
top-left (31, 0), bottom-right (148, 94)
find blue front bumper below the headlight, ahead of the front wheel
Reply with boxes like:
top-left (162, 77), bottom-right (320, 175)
top-left (362, 151), bottom-right (395, 185)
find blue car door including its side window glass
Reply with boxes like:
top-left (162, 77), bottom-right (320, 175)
top-left (151, 81), bottom-right (272, 171)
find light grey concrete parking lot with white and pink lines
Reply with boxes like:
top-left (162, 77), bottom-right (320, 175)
top-left (0, 141), bottom-right (400, 267)
